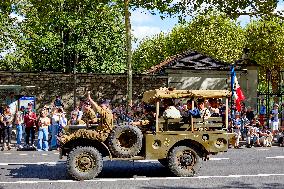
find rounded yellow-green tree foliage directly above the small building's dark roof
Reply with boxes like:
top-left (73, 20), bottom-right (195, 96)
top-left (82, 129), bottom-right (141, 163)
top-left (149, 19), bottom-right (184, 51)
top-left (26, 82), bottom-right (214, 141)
top-left (133, 12), bottom-right (245, 72)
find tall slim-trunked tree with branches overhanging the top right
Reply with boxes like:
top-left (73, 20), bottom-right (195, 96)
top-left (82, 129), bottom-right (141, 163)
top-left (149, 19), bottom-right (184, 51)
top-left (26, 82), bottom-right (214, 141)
top-left (120, 0), bottom-right (283, 105)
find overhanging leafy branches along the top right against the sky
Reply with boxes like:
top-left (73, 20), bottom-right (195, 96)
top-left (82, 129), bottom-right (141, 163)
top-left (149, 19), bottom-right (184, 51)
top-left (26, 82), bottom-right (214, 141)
top-left (127, 0), bottom-right (283, 18)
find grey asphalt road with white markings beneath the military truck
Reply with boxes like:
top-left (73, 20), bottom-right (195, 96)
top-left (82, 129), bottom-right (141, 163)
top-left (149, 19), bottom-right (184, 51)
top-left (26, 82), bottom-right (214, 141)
top-left (0, 146), bottom-right (284, 189)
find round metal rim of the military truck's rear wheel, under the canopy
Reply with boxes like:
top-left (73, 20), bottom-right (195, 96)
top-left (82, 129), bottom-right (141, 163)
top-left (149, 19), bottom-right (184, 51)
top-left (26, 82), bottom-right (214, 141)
top-left (177, 150), bottom-right (196, 170)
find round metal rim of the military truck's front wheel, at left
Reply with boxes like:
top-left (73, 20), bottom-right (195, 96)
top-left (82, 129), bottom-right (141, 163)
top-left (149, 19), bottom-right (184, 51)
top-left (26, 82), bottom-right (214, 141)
top-left (76, 153), bottom-right (95, 172)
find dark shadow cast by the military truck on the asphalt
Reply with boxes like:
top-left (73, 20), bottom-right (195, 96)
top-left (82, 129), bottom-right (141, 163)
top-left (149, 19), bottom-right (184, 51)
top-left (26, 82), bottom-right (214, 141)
top-left (6, 161), bottom-right (173, 180)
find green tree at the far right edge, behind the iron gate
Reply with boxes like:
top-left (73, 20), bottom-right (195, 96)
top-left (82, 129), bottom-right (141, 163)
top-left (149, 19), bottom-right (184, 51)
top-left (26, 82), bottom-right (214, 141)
top-left (246, 18), bottom-right (284, 93)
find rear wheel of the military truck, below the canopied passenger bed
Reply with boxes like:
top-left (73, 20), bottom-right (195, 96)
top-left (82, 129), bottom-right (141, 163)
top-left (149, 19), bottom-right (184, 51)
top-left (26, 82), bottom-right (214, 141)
top-left (168, 146), bottom-right (200, 177)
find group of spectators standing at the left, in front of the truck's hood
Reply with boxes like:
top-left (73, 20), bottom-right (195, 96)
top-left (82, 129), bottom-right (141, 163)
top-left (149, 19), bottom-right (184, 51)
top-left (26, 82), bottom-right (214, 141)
top-left (0, 96), bottom-right (67, 151)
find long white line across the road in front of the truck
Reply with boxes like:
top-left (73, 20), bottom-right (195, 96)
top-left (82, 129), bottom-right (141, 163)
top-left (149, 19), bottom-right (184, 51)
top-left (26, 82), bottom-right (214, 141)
top-left (0, 173), bottom-right (284, 184)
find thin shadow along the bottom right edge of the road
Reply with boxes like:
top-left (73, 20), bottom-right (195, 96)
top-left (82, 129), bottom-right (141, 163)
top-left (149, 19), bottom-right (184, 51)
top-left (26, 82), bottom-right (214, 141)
top-left (141, 182), bottom-right (284, 189)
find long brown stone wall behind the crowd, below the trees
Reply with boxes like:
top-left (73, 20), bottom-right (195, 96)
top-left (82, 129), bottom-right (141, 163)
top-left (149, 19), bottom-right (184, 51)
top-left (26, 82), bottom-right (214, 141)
top-left (0, 72), bottom-right (167, 110)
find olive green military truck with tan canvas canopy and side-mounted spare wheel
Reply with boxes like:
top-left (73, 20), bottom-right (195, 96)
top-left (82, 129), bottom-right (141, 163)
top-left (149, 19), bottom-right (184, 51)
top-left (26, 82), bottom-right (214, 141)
top-left (59, 88), bottom-right (232, 180)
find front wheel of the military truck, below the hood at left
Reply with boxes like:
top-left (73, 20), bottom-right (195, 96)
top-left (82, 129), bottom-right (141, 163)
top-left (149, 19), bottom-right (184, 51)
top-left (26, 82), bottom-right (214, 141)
top-left (66, 146), bottom-right (103, 180)
